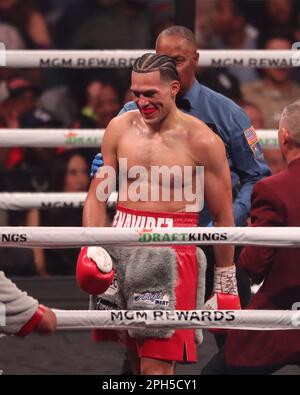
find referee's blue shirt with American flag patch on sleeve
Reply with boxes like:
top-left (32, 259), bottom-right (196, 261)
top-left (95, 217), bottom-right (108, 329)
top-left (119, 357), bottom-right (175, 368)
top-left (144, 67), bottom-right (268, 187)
top-left (120, 80), bottom-right (271, 226)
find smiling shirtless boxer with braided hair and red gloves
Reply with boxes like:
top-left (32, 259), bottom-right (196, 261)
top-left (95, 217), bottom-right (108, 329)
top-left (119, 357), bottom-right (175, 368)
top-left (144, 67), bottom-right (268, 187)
top-left (77, 54), bottom-right (239, 374)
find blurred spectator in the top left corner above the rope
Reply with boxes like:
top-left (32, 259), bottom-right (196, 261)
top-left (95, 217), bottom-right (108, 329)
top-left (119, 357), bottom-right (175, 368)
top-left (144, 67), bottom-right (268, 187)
top-left (0, 0), bottom-right (52, 49)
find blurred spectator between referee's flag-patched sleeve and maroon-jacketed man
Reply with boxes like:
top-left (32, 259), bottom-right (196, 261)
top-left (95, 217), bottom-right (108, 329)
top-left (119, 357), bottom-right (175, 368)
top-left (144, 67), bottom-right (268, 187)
top-left (240, 102), bottom-right (286, 174)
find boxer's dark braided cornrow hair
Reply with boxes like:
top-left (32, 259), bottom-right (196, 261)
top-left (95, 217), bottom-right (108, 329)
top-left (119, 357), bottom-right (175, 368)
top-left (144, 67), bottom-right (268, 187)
top-left (133, 53), bottom-right (179, 81)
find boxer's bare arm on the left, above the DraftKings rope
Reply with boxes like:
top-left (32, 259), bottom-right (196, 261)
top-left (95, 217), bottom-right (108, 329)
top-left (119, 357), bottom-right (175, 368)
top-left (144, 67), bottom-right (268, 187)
top-left (83, 118), bottom-right (120, 227)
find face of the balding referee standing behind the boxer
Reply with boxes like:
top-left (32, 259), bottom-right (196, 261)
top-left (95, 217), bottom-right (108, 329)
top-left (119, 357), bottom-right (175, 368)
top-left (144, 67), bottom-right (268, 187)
top-left (156, 34), bottom-right (199, 95)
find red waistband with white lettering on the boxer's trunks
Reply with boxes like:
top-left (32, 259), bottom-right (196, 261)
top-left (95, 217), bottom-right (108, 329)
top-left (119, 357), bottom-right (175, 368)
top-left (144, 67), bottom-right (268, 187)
top-left (113, 205), bottom-right (199, 229)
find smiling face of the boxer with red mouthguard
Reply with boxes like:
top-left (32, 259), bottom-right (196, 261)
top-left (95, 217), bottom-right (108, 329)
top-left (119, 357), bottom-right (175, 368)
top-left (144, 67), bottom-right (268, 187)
top-left (131, 71), bottom-right (180, 124)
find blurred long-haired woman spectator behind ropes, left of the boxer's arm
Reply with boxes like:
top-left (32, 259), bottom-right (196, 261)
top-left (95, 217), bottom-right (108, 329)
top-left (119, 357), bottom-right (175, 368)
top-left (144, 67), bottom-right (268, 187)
top-left (27, 150), bottom-right (89, 275)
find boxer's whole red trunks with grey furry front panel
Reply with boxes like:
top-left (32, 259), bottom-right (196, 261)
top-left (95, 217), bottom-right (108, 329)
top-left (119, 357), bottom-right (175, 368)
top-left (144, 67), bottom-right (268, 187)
top-left (93, 205), bottom-right (199, 362)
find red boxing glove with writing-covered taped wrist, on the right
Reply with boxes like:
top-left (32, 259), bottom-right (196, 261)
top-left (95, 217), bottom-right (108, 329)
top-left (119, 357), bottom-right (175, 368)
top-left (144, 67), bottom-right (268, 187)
top-left (204, 265), bottom-right (241, 334)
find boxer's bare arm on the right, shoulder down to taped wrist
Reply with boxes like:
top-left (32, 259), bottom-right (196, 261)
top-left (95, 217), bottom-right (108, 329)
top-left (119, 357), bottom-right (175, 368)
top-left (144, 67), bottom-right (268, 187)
top-left (192, 128), bottom-right (234, 267)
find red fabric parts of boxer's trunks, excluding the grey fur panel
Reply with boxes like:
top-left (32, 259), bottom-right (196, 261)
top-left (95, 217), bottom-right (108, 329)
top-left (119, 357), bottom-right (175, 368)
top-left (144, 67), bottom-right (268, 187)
top-left (93, 205), bottom-right (199, 362)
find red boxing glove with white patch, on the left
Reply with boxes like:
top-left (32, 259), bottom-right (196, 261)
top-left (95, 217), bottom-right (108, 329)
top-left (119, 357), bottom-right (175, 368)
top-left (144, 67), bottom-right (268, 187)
top-left (76, 247), bottom-right (114, 295)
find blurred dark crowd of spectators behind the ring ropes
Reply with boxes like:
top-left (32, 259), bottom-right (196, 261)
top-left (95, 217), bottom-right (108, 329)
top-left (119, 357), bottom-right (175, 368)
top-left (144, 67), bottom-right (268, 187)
top-left (0, 0), bottom-right (300, 275)
